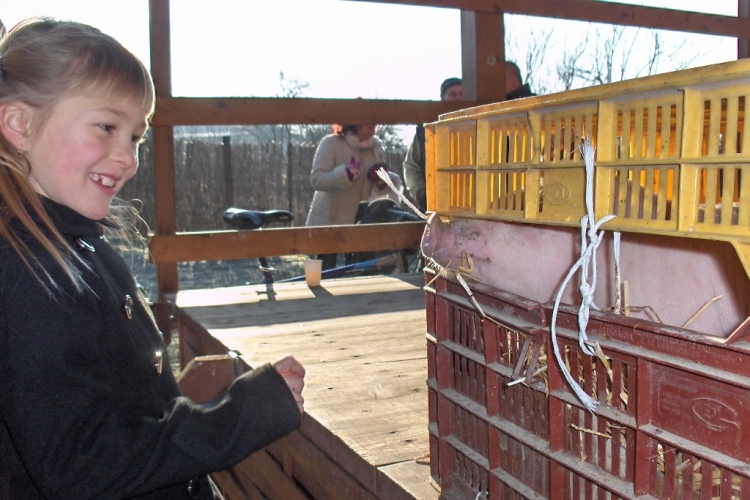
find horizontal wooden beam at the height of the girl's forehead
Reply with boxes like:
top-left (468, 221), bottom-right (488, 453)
top-left (152, 97), bottom-right (476, 126)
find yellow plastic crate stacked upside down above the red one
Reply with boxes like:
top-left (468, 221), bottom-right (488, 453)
top-left (427, 60), bottom-right (750, 278)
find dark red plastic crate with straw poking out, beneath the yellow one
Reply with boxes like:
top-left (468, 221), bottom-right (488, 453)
top-left (427, 278), bottom-right (750, 500)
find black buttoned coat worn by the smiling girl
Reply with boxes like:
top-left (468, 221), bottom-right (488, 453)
top-left (0, 199), bottom-right (301, 500)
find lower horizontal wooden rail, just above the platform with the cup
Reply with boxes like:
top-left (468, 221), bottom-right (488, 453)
top-left (149, 222), bottom-right (425, 265)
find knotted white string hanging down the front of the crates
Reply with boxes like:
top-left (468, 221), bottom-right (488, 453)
top-left (550, 139), bottom-right (615, 413)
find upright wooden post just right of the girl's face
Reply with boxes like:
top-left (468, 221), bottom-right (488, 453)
top-left (149, 0), bottom-right (179, 296)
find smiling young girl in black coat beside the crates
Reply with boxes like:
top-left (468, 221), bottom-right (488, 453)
top-left (0, 19), bottom-right (304, 499)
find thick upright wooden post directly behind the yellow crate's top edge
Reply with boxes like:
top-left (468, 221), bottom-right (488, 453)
top-left (461, 10), bottom-right (505, 103)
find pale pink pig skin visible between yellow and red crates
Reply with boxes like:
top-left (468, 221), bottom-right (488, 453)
top-left (422, 216), bottom-right (750, 338)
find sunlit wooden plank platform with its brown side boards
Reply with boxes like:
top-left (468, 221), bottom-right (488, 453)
top-left (175, 275), bottom-right (440, 500)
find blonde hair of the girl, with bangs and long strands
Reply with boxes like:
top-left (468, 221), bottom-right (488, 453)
top-left (0, 18), bottom-right (155, 290)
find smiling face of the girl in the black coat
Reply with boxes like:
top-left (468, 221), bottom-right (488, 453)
top-left (24, 96), bottom-right (148, 220)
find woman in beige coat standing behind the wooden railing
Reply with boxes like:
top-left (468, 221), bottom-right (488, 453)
top-left (306, 125), bottom-right (401, 270)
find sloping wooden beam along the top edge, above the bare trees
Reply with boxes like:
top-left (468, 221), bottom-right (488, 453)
top-left (354, 0), bottom-right (750, 37)
